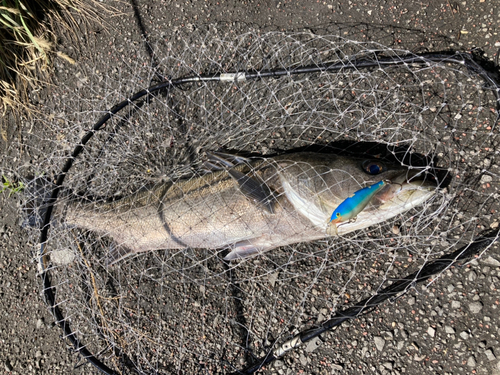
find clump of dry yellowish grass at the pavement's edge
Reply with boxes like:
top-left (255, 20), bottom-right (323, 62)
top-left (0, 0), bottom-right (103, 128)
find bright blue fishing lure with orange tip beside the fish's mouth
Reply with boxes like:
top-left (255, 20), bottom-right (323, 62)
top-left (328, 180), bottom-right (390, 234)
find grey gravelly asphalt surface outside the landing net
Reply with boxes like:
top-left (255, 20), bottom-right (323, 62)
top-left (0, 0), bottom-right (500, 374)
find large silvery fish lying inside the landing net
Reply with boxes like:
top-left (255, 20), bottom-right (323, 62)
top-left (48, 152), bottom-right (438, 266)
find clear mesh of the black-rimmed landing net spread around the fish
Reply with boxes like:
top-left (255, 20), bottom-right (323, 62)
top-left (6, 27), bottom-right (500, 374)
